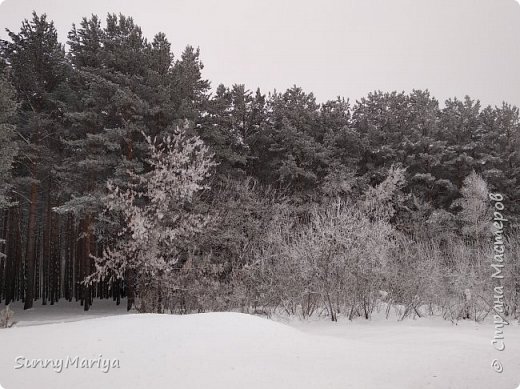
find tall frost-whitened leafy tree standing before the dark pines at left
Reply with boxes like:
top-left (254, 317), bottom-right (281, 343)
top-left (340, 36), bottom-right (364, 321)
top-left (86, 129), bottom-right (215, 311)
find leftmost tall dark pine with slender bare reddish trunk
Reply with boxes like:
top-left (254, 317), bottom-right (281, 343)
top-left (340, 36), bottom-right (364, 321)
top-left (1, 13), bottom-right (70, 309)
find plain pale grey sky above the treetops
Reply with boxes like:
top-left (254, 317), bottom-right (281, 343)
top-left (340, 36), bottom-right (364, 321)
top-left (0, 0), bottom-right (520, 105)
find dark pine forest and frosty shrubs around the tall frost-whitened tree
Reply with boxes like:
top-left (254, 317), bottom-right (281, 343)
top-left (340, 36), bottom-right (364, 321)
top-left (0, 14), bottom-right (520, 317)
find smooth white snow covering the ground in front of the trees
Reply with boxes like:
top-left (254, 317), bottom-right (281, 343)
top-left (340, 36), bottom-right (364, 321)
top-left (0, 303), bottom-right (520, 389)
